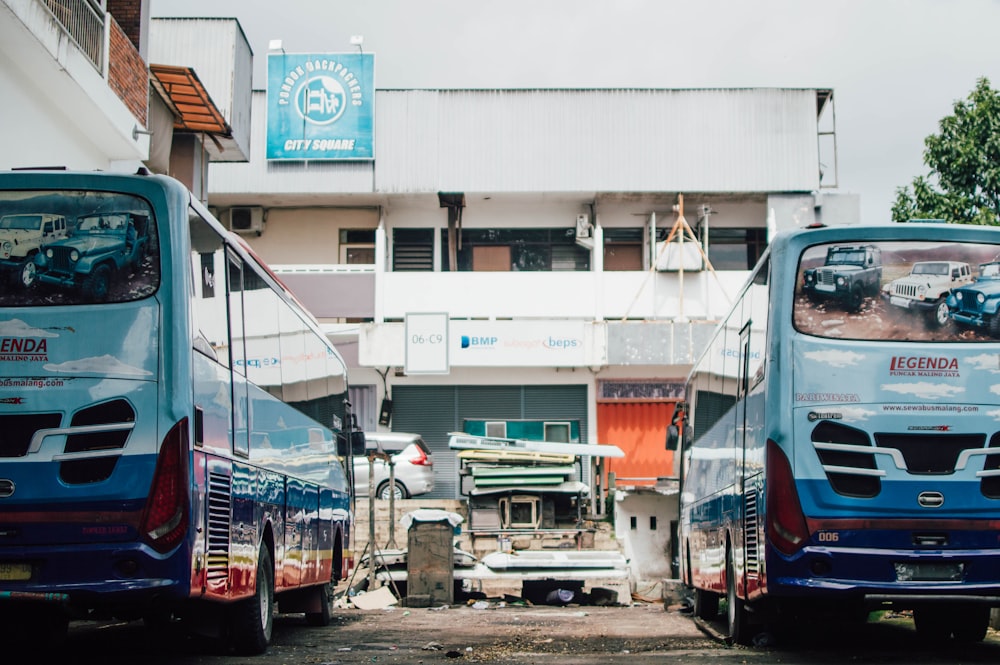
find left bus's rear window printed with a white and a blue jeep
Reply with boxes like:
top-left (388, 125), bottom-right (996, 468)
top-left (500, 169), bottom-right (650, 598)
top-left (0, 191), bottom-right (160, 307)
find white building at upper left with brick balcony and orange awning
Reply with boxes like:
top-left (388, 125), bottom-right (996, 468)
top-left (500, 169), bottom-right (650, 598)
top-left (0, 0), bottom-right (253, 200)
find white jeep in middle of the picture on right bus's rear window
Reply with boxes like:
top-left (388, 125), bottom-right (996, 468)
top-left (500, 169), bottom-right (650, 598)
top-left (882, 261), bottom-right (972, 326)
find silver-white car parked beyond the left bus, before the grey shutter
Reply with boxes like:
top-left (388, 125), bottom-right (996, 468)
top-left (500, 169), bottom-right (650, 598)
top-left (354, 432), bottom-right (434, 499)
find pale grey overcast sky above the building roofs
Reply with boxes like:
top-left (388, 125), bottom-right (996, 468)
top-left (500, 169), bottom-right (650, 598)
top-left (152, 0), bottom-right (1000, 222)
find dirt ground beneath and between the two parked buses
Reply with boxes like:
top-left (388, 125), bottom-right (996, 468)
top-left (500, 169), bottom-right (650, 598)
top-left (15, 600), bottom-right (1000, 665)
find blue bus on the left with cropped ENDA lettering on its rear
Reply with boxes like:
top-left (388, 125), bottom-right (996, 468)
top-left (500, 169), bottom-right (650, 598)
top-left (0, 171), bottom-right (364, 654)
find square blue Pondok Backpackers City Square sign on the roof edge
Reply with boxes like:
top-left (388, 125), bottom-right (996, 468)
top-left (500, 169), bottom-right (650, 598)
top-left (267, 53), bottom-right (375, 160)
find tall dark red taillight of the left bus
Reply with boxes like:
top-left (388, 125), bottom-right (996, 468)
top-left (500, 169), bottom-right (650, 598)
top-left (142, 418), bottom-right (188, 552)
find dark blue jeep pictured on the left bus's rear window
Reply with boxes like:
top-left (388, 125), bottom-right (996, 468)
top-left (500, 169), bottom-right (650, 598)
top-left (35, 212), bottom-right (149, 302)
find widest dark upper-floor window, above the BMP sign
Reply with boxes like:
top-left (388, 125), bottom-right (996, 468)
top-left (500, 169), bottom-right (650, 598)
top-left (441, 228), bottom-right (590, 272)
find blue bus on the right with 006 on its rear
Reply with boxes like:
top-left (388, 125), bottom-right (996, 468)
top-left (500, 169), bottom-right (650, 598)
top-left (667, 224), bottom-right (1000, 644)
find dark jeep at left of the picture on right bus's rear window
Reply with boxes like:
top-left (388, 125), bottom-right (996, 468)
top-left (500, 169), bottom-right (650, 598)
top-left (802, 245), bottom-right (882, 312)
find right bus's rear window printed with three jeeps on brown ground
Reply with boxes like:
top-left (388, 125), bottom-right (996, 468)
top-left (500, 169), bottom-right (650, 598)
top-left (792, 240), bottom-right (1000, 342)
